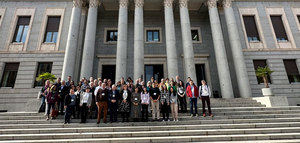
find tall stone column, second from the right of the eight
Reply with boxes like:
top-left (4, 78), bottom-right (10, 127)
top-left (207, 0), bottom-right (234, 98)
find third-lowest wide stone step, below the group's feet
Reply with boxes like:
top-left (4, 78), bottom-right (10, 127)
top-left (0, 122), bottom-right (300, 134)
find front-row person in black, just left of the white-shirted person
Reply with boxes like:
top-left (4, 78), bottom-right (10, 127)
top-left (64, 89), bottom-right (76, 124)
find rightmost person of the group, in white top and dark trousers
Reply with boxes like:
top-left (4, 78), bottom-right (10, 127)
top-left (199, 80), bottom-right (213, 117)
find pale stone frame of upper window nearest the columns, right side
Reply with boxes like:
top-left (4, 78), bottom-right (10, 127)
top-left (239, 7), bottom-right (267, 49)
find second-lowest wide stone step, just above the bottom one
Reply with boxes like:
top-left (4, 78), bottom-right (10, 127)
top-left (0, 127), bottom-right (300, 140)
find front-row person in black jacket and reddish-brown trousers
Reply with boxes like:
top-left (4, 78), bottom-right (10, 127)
top-left (96, 83), bottom-right (108, 124)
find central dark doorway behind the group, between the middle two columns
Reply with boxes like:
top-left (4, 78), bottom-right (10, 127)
top-left (145, 65), bottom-right (164, 82)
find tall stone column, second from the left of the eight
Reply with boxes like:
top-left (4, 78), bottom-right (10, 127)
top-left (80, 0), bottom-right (100, 78)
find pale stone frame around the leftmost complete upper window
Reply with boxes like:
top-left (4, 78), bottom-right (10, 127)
top-left (5, 8), bottom-right (35, 52)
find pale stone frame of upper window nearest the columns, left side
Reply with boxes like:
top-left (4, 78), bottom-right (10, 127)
top-left (37, 8), bottom-right (65, 51)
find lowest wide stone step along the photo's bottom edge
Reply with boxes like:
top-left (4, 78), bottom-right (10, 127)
top-left (1, 133), bottom-right (300, 143)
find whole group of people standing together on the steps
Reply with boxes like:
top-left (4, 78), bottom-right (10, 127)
top-left (39, 76), bottom-right (213, 124)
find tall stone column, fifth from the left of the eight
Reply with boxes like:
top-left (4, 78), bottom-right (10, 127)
top-left (164, 0), bottom-right (178, 79)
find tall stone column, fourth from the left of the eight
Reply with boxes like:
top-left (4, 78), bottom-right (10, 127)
top-left (133, 0), bottom-right (144, 80)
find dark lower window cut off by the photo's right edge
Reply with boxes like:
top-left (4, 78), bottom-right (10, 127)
top-left (283, 59), bottom-right (300, 83)
